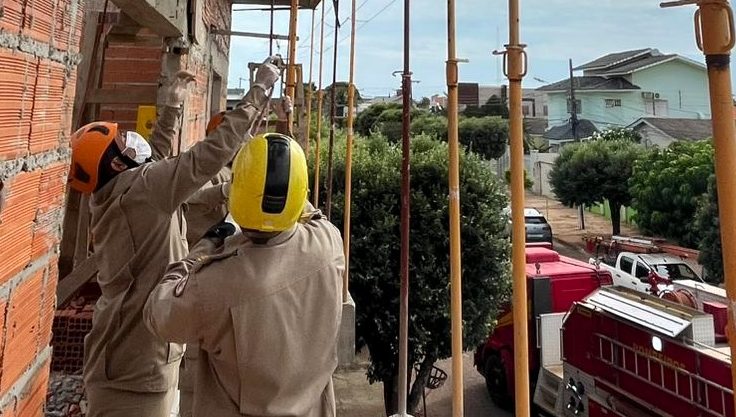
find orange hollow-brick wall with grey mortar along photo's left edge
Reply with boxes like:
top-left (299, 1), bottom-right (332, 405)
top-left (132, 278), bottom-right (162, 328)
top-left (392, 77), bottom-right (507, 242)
top-left (0, 0), bottom-right (83, 417)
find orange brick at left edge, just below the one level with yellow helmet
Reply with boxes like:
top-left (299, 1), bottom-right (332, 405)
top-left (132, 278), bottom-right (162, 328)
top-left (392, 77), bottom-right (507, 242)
top-left (0, 270), bottom-right (45, 395)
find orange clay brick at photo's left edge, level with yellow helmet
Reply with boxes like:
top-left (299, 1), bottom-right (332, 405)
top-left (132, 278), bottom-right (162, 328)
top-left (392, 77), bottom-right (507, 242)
top-left (0, 171), bottom-right (41, 285)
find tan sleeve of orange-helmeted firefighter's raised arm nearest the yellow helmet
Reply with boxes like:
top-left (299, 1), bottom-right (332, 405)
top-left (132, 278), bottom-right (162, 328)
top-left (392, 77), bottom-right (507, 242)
top-left (131, 88), bottom-right (268, 213)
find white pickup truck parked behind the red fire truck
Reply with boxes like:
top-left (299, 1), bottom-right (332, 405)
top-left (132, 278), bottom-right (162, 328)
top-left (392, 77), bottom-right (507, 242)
top-left (588, 252), bottom-right (704, 293)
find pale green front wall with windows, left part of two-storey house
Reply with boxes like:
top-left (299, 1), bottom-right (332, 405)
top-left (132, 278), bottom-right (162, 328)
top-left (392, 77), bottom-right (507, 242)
top-left (548, 91), bottom-right (644, 130)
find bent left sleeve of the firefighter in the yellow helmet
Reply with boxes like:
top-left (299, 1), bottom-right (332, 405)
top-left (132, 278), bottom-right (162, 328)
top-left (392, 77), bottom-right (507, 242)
top-left (143, 258), bottom-right (202, 343)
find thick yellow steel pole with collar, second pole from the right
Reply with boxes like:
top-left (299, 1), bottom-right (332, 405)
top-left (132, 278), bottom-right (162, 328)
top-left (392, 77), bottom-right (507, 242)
top-left (506, 0), bottom-right (530, 417)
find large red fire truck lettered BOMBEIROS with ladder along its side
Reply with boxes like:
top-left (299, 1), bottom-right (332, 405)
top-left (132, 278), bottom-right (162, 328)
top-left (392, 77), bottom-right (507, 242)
top-left (475, 248), bottom-right (734, 417)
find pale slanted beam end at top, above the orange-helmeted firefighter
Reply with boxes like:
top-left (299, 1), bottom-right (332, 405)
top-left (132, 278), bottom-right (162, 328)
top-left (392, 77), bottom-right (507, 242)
top-left (112, 0), bottom-right (187, 38)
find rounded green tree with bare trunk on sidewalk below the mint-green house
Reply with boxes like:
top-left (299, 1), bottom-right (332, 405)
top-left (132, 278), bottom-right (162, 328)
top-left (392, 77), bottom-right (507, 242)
top-left (549, 139), bottom-right (641, 235)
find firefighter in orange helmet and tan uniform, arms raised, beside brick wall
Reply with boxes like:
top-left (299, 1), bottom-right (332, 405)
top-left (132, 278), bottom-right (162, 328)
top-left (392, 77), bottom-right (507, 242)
top-left (70, 57), bottom-right (279, 417)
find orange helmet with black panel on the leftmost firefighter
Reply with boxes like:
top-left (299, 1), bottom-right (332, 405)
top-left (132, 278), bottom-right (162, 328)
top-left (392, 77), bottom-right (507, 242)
top-left (69, 122), bottom-right (118, 194)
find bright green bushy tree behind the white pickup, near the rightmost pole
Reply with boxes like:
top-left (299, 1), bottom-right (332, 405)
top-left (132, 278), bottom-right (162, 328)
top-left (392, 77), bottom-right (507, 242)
top-left (629, 141), bottom-right (714, 247)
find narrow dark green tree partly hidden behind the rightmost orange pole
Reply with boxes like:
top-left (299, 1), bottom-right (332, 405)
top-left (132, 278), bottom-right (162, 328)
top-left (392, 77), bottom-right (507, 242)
top-left (694, 175), bottom-right (723, 285)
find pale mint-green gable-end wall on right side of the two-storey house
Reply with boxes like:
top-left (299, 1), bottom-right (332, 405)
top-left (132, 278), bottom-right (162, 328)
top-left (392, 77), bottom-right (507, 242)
top-left (632, 61), bottom-right (710, 119)
